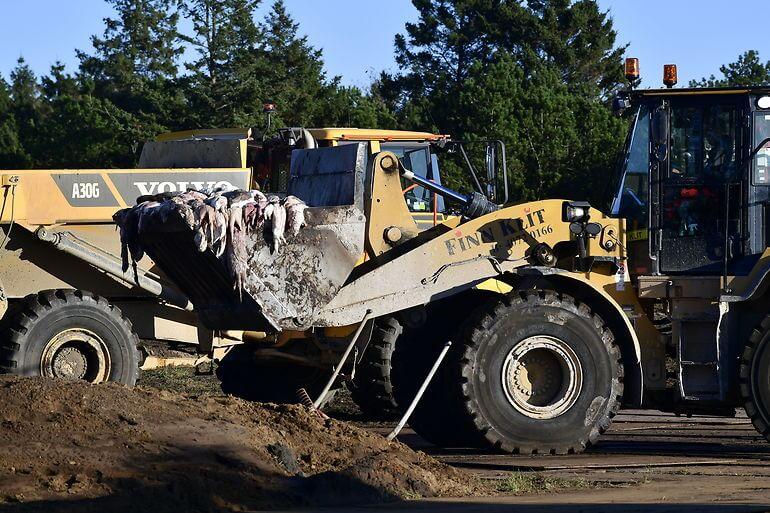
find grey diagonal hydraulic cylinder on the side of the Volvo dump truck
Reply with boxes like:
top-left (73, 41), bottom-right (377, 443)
top-left (35, 226), bottom-right (193, 311)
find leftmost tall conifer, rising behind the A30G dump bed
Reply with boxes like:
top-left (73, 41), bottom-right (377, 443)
top-left (65, 0), bottom-right (184, 166)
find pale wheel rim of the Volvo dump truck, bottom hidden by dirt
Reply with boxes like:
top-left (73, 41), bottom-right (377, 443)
top-left (40, 328), bottom-right (110, 383)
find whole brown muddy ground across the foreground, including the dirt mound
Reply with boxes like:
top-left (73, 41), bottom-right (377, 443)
top-left (6, 368), bottom-right (770, 513)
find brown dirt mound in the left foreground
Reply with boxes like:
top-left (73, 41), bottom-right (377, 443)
top-left (0, 376), bottom-right (481, 512)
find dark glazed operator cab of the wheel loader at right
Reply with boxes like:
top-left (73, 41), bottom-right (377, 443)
top-left (611, 88), bottom-right (770, 276)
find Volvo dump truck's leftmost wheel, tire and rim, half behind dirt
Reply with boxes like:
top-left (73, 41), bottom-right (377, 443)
top-left (0, 290), bottom-right (140, 386)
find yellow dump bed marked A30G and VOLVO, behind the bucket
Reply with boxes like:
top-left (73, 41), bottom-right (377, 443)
top-left (0, 168), bottom-right (251, 343)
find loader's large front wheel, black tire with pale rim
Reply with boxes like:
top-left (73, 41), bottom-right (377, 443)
top-left (454, 290), bottom-right (623, 454)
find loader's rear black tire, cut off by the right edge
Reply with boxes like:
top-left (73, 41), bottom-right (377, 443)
top-left (738, 315), bottom-right (770, 441)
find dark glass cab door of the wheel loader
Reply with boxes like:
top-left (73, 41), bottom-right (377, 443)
top-left (656, 97), bottom-right (744, 275)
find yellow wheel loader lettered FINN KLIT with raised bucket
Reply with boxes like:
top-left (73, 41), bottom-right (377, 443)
top-left (132, 60), bottom-right (770, 454)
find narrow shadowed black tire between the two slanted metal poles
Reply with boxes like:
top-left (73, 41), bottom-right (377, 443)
top-left (350, 317), bottom-right (403, 420)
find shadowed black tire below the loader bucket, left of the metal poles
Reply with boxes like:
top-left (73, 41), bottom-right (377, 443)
top-left (216, 345), bottom-right (336, 407)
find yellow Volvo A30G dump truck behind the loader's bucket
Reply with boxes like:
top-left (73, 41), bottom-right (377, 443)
top-left (0, 129), bottom-right (480, 390)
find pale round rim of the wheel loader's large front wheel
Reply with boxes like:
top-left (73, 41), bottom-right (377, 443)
top-left (502, 335), bottom-right (583, 419)
